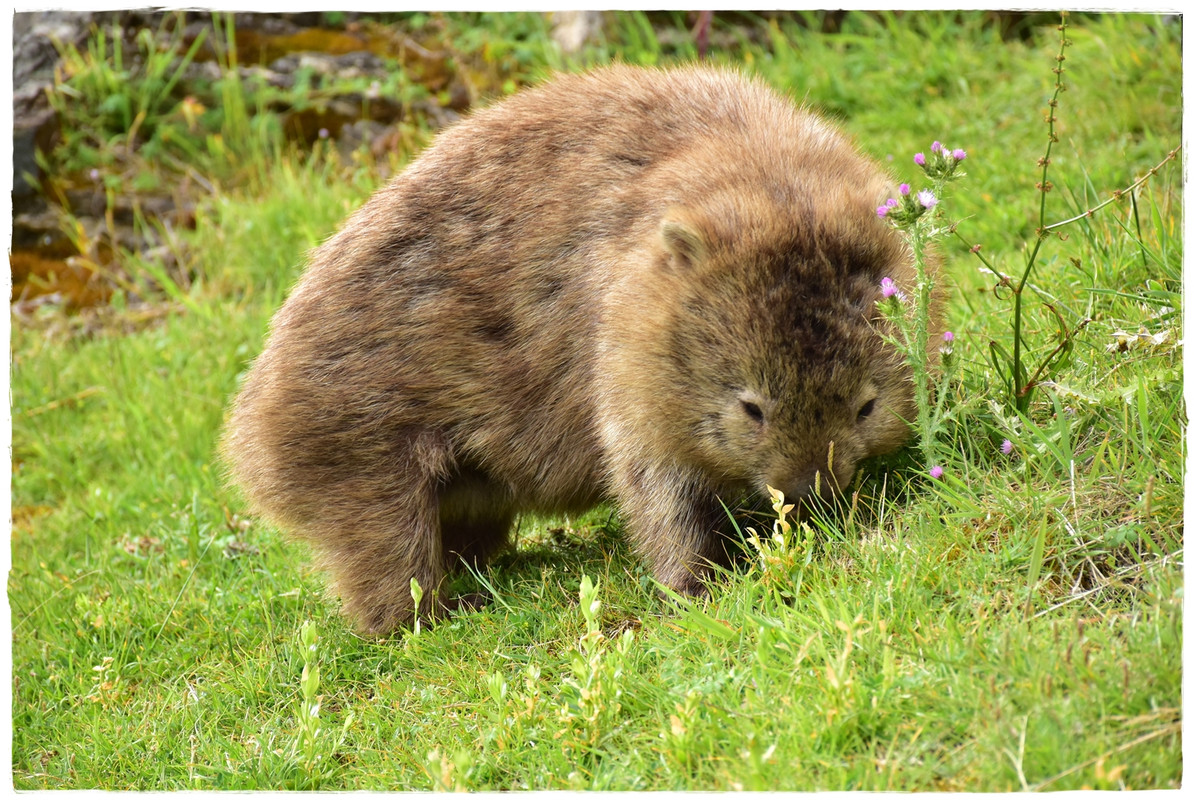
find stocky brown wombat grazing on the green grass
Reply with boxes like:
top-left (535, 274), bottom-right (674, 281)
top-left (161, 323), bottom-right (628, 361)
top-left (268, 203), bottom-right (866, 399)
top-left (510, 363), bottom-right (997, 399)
top-left (224, 66), bottom-right (931, 633)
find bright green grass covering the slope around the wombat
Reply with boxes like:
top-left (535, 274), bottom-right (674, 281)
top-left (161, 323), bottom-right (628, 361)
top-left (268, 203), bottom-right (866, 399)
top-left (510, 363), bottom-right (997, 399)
top-left (8, 13), bottom-right (1186, 790)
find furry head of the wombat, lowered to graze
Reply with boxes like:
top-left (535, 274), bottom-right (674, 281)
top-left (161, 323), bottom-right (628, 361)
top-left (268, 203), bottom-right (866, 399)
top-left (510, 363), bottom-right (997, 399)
top-left (656, 196), bottom-right (936, 508)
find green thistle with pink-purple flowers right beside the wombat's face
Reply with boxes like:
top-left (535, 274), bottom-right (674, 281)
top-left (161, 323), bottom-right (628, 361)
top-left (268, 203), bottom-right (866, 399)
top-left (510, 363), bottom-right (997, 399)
top-left (875, 141), bottom-right (966, 478)
